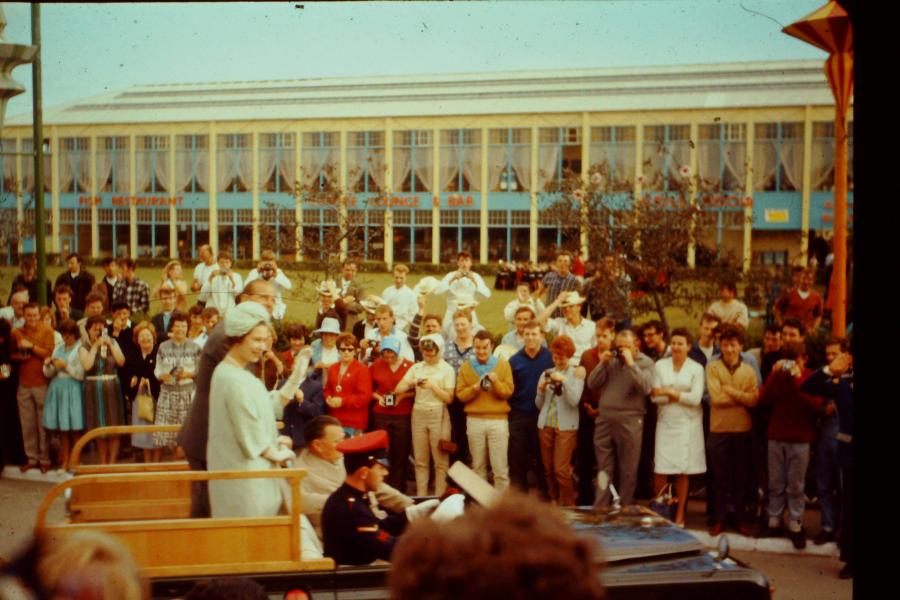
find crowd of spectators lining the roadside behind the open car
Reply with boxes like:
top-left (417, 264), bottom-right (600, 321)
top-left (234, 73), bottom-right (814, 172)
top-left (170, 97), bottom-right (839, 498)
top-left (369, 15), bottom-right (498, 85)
top-left (0, 247), bottom-right (852, 573)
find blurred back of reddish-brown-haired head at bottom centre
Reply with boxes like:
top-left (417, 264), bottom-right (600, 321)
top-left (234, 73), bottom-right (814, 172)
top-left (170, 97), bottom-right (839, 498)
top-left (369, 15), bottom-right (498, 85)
top-left (388, 492), bottom-right (603, 600)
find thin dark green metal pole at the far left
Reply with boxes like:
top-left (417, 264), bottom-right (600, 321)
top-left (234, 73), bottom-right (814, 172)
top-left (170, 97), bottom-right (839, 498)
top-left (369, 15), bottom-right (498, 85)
top-left (31, 2), bottom-right (49, 306)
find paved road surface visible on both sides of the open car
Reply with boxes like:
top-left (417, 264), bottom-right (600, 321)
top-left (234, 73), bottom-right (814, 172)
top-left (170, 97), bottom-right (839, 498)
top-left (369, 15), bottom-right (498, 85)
top-left (0, 468), bottom-right (853, 600)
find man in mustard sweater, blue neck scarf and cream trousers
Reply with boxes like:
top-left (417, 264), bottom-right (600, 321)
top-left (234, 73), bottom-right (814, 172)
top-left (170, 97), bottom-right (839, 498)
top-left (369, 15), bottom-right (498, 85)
top-left (456, 330), bottom-right (513, 491)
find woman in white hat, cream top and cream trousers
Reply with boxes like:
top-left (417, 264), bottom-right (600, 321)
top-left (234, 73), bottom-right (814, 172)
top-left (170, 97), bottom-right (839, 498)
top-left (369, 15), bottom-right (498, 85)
top-left (394, 333), bottom-right (456, 496)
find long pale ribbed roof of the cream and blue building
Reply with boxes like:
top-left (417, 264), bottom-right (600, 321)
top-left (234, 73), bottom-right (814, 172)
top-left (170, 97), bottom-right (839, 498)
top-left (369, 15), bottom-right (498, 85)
top-left (5, 60), bottom-right (834, 126)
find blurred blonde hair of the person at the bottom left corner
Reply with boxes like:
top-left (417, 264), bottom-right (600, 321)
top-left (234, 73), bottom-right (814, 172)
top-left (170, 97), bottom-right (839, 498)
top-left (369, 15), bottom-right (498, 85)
top-left (37, 531), bottom-right (150, 600)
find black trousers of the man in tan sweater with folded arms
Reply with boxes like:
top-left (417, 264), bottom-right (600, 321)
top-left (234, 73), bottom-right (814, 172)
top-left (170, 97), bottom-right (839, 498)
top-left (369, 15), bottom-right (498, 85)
top-left (706, 431), bottom-right (754, 524)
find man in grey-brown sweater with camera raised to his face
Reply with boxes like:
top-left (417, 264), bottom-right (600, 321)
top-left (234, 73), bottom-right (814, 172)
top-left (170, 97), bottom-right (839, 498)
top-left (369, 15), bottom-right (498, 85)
top-left (587, 329), bottom-right (654, 507)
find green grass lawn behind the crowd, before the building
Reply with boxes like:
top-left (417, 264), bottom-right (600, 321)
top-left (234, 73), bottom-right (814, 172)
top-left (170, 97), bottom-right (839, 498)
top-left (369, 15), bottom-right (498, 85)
top-left (0, 266), bottom-right (744, 335)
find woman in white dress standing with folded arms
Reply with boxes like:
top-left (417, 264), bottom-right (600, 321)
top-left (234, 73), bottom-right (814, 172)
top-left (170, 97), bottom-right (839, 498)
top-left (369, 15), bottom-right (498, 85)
top-left (651, 327), bottom-right (706, 527)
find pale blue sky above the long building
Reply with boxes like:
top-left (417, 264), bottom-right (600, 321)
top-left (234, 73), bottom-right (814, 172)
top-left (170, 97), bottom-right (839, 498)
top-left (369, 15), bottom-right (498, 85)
top-left (3, 0), bottom-right (826, 116)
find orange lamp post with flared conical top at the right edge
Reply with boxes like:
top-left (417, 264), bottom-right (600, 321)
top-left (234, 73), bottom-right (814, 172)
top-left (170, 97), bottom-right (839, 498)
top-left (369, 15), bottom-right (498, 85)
top-left (783, 0), bottom-right (853, 337)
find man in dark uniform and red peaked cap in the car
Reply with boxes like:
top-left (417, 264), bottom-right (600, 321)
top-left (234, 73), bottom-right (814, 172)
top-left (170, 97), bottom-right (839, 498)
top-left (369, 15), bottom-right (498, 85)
top-left (322, 429), bottom-right (439, 565)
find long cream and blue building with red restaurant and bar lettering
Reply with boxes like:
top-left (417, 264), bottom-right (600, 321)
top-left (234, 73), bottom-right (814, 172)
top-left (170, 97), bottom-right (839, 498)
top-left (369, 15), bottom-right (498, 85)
top-left (0, 61), bottom-right (853, 265)
